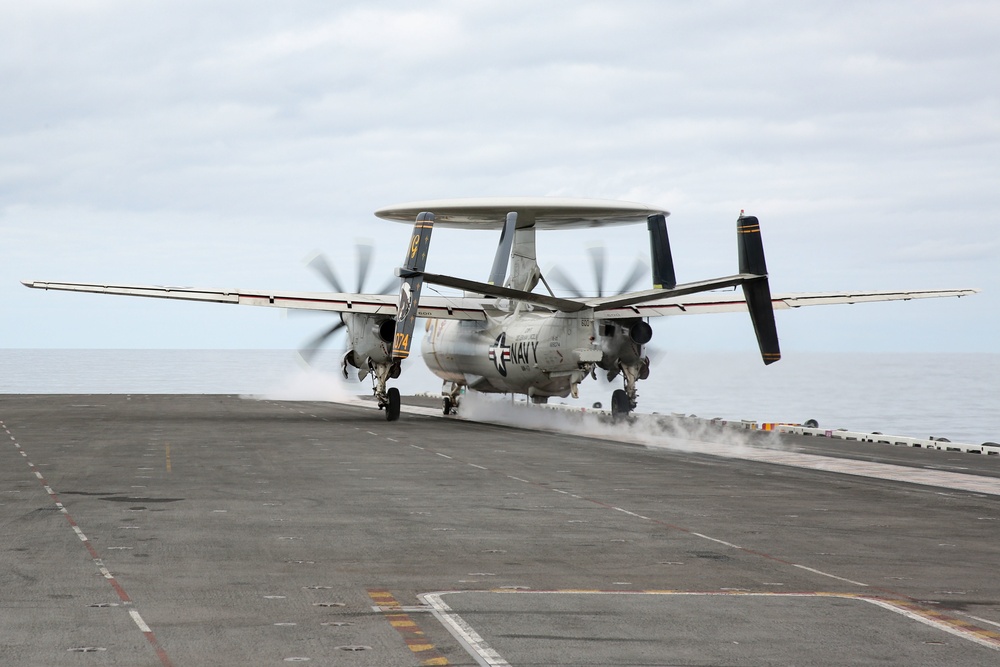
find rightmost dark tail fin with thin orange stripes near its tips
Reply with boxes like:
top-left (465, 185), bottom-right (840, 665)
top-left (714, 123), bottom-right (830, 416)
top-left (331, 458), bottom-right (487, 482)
top-left (736, 212), bottom-right (781, 364)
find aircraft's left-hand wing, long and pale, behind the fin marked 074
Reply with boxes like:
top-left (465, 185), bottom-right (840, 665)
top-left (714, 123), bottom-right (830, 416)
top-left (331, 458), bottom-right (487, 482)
top-left (21, 280), bottom-right (493, 320)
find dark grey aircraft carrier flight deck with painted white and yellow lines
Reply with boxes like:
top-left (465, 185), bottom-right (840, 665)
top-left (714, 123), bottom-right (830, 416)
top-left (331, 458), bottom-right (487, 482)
top-left (0, 395), bottom-right (1000, 667)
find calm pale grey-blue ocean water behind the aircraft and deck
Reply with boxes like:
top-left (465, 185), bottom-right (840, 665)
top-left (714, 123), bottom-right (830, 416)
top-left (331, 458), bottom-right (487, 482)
top-left (0, 349), bottom-right (1000, 444)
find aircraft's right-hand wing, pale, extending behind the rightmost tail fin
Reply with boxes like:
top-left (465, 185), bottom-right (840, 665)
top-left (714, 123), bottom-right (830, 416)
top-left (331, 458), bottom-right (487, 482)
top-left (597, 289), bottom-right (979, 319)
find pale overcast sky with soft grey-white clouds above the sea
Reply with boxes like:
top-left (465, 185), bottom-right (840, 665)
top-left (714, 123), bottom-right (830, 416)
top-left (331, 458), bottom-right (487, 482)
top-left (0, 0), bottom-right (1000, 352)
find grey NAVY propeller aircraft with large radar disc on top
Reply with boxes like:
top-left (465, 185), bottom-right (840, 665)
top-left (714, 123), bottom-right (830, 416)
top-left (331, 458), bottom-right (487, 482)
top-left (23, 197), bottom-right (978, 421)
